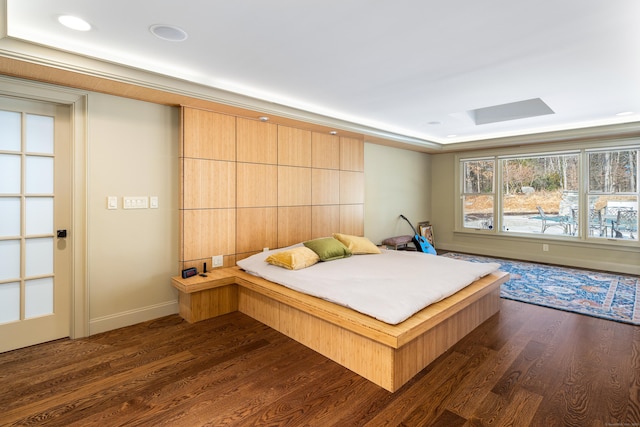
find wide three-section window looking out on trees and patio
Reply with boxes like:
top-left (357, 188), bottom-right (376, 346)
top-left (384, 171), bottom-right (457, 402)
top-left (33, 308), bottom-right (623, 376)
top-left (460, 146), bottom-right (640, 242)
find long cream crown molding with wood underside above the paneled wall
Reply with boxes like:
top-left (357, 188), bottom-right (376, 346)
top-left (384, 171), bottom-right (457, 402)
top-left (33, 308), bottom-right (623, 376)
top-left (0, 33), bottom-right (442, 151)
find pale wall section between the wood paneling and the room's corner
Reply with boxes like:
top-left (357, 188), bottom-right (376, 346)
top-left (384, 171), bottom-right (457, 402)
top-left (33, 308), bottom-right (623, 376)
top-left (364, 143), bottom-right (431, 244)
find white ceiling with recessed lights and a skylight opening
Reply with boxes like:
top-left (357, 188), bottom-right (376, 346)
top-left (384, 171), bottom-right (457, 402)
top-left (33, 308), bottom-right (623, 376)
top-left (6, 0), bottom-right (640, 144)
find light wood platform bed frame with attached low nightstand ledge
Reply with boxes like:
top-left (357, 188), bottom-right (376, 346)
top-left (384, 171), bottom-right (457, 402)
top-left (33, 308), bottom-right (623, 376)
top-left (172, 267), bottom-right (508, 392)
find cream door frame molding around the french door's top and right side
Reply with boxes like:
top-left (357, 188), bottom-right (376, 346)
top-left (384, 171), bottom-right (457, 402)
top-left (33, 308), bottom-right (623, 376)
top-left (0, 76), bottom-right (89, 339)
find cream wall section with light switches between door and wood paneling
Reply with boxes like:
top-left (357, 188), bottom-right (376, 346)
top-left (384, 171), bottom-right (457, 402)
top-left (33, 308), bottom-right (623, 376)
top-left (87, 93), bottom-right (179, 334)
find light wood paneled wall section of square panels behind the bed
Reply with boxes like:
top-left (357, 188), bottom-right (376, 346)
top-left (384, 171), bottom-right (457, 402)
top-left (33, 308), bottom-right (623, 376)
top-left (180, 107), bottom-right (364, 270)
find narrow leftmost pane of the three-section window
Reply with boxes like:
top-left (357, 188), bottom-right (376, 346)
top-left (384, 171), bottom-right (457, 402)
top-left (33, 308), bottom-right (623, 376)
top-left (462, 159), bottom-right (495, 230)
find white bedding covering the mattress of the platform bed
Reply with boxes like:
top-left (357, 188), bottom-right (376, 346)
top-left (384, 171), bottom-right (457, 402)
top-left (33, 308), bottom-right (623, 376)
top-left (237, 245), bottom-right (500, 325)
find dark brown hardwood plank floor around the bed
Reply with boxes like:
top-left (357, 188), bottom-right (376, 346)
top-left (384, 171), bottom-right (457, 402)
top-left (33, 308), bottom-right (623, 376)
top-left (0, 300), bottom-right (640, 427)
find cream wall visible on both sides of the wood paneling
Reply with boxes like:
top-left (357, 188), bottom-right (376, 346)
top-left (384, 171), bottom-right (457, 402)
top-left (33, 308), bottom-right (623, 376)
top-left (82, 97), bottom-right (431, 334)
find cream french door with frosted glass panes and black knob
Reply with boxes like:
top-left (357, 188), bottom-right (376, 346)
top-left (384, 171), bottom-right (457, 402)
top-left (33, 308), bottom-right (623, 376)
top-left (0, 97), bottom-right (72, 352)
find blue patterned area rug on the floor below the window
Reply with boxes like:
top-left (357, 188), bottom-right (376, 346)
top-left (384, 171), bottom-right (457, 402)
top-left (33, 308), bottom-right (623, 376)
top-left (442, 252), bottom-right (640, 325)
